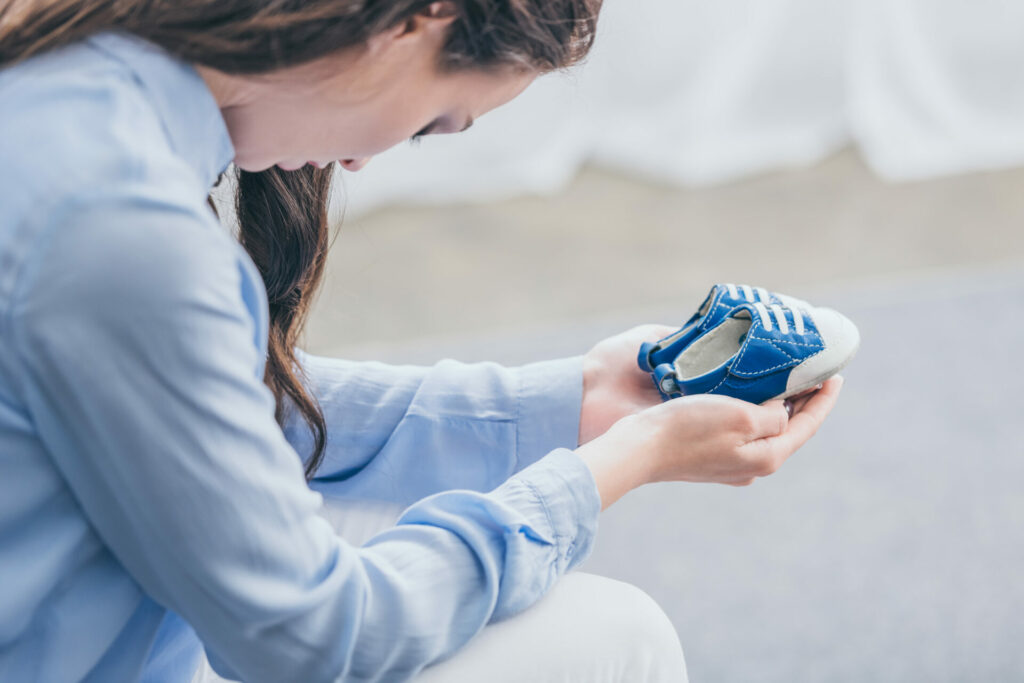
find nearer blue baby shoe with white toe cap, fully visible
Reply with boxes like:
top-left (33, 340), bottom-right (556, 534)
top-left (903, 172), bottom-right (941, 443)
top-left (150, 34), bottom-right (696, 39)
top-left (653, 301), bottom-right (860, 403)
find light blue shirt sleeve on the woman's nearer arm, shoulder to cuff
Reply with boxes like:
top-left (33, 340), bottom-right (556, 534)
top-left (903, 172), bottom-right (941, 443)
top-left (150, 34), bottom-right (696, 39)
top-left (9, 194), bottom-right (600, 681)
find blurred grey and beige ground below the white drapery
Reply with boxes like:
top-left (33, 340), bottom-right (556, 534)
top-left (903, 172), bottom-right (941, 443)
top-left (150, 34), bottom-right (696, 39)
top-left (308, 147), bottom-right (1024, 682)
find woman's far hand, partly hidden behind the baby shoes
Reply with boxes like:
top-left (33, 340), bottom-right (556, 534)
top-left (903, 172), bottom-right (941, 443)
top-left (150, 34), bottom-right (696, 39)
top-left (580, 325), bottom-right (678, 445)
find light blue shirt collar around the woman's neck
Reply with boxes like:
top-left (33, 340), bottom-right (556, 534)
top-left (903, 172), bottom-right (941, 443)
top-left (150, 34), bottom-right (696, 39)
top-left (89, 33), bottom-right (234, 186)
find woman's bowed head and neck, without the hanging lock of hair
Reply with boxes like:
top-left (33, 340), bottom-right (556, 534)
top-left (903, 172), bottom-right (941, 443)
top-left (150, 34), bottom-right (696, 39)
top-left (0, 0), bottom-right (600, 171)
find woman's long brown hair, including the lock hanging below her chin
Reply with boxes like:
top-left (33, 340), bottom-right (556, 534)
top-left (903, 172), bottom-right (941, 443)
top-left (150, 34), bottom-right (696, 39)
top-left (0, 0), bottom-right (601, 477)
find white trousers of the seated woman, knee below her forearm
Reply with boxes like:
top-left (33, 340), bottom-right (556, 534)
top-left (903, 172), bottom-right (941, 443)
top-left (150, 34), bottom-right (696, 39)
top-left (193, 503), bottom-right (687, 683)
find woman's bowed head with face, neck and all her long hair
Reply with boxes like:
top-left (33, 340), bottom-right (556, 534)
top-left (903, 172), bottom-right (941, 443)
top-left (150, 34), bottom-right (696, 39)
top-left (0, 0), bottom-right (601, 475)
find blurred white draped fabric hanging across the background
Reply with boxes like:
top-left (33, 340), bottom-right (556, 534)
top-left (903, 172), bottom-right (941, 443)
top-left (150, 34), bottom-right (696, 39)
top-left (339, 0), bottom-right (1024, 212)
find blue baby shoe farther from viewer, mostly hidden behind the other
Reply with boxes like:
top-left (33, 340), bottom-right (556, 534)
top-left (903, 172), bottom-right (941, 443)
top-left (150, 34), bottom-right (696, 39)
top-left (637, 284), bottom-right (811, 373)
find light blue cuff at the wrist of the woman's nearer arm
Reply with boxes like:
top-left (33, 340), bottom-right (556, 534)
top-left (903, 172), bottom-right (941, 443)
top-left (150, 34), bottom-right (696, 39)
top-left (492, 449), bottom-right (601, 580)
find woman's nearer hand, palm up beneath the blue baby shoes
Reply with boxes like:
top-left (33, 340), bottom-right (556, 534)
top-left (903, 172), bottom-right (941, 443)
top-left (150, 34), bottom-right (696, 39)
top-left (577, 377), bottom-right (843, 509)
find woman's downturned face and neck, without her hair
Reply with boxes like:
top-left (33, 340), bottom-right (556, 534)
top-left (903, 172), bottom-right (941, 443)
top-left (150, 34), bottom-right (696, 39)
top-left (198, 3), bottom-right (536, 171)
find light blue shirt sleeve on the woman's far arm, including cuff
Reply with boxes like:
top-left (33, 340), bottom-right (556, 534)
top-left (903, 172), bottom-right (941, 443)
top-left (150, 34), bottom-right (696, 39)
top-left (285, 351), bottom-right (583, 504)
